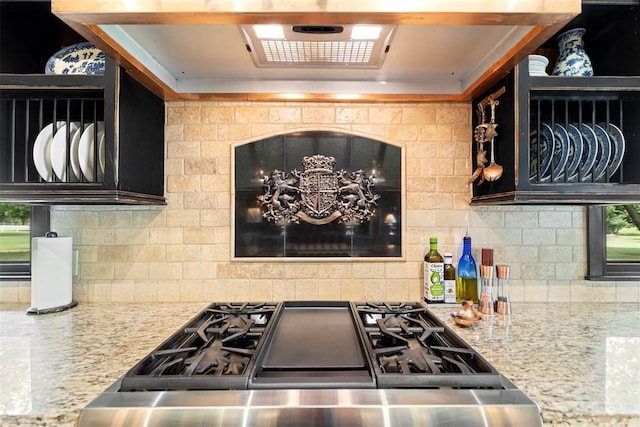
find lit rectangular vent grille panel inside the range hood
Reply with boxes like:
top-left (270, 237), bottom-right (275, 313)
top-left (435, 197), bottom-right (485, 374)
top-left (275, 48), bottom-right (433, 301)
top-left (240, 25), bottom-right (396, 68)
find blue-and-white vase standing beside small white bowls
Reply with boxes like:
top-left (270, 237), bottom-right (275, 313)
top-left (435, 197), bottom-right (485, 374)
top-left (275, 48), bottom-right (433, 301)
top-left (553, 28), bottom-right (593, 77)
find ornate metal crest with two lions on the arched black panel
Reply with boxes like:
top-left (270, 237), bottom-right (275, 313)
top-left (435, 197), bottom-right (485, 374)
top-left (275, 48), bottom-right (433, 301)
top-left (258, 154), bottom-right (380, 225)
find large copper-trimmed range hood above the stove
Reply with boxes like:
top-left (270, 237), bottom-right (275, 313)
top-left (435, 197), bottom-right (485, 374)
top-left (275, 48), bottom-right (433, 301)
top-left (52, 0), bottom-right (581, 102)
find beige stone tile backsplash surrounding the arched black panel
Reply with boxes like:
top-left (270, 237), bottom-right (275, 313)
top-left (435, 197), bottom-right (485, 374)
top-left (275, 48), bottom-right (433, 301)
top-left (0, 102), bottom-right (640, 303)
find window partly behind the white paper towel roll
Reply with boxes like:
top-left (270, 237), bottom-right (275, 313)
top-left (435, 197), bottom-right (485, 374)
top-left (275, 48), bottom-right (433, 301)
top-left (0, 203), bottom-right (49, 280)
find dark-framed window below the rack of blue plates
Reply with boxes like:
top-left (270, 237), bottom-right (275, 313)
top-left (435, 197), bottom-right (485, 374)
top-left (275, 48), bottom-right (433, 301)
top-left (587, 204), bottom-right (640, 280)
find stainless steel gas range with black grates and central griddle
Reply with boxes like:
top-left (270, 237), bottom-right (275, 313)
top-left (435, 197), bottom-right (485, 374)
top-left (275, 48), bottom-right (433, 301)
top-left (79, 301), bottom-right (541, 426)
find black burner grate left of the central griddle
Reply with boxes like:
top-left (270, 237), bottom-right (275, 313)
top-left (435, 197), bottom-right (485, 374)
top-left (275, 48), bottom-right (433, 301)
top-left (122, 303), bottom-right (278, 391)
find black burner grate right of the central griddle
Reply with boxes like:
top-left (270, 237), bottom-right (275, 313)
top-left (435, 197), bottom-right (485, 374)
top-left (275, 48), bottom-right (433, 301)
top-left (354, 303), bottom-right (502, 388)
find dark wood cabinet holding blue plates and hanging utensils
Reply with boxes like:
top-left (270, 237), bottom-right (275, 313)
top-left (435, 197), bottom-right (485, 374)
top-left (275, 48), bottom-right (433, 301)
top-left (471, 1), bottom-right (640, 205)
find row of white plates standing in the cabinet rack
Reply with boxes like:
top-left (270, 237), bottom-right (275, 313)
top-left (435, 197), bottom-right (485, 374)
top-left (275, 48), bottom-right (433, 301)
top-left (33, 121), bottom-right (105, 182)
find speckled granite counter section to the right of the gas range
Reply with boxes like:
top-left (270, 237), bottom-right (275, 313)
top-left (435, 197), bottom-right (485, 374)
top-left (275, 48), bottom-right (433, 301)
top-left (434, 303), bottom-right (640, 427)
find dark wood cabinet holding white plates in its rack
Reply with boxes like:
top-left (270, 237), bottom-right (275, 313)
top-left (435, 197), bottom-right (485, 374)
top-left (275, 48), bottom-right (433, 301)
top-left (0, 1), bottom-right (165, 204)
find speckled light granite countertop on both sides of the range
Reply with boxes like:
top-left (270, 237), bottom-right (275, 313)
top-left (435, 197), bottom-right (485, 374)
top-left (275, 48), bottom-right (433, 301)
top-left (0, 303), bottom-right (640, 427)
